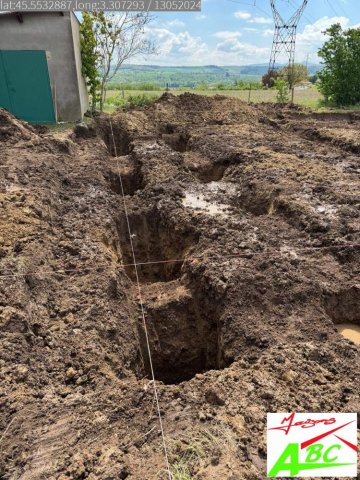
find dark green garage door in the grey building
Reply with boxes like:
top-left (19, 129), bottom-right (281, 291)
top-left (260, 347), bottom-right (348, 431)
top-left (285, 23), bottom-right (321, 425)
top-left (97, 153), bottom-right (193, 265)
top-left (0, 50), bottom-right (55, 123)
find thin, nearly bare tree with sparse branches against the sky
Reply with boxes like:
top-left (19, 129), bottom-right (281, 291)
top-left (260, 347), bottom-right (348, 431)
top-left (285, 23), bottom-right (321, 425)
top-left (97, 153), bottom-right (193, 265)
top-left (93, 12), bottom-right (156, 111)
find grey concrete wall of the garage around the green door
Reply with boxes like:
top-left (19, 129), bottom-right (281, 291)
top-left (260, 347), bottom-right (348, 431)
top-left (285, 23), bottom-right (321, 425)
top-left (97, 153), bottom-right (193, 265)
top-left (0, 12), bottom-right (88, 122)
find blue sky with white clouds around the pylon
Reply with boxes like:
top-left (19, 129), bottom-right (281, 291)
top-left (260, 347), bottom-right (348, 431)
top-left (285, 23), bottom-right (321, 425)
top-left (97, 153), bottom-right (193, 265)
top-left (129, 0), bottom-right (360, 66)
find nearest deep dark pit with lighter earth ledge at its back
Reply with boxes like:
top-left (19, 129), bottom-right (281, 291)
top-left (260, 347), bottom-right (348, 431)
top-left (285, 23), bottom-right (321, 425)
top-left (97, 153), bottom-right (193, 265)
top-left (139, 280), bottom-right (225, 384)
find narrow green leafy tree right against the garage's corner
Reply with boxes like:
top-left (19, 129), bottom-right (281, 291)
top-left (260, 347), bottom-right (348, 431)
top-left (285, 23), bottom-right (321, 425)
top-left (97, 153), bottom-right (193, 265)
top-left (80, 12), bottom-right (100, 113)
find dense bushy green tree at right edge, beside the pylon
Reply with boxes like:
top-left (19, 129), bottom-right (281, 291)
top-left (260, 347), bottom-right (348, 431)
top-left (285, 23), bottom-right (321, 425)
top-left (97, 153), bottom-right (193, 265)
top-left (318, 23), bottom-right (360, 105)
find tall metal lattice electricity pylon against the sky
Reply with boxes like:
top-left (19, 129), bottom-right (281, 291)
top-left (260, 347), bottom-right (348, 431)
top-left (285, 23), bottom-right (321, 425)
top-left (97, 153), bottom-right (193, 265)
top-left (269, 0), bottom-right (309, 88)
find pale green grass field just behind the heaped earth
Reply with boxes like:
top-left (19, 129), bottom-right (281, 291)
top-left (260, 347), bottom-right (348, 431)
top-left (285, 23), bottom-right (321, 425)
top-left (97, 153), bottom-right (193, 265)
top-left (105, 87), bottom-right (323, 113)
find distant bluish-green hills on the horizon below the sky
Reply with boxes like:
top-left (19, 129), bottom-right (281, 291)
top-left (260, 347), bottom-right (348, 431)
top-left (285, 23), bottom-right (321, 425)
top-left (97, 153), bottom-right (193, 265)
top-left (111, 64), bottom-right (321, 88)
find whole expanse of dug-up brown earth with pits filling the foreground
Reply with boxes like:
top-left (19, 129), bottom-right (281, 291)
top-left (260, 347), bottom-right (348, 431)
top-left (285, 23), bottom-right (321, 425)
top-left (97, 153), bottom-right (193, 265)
top-left (0, 94), bottom-right (360, 480)
